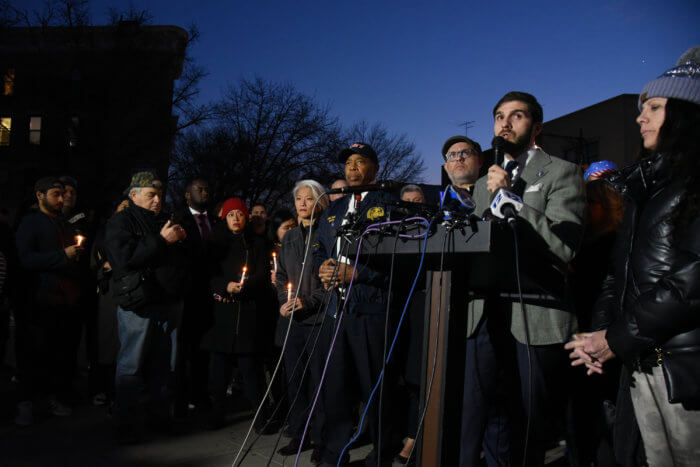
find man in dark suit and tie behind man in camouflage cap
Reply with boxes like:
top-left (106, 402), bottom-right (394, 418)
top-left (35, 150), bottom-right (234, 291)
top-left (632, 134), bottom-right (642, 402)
top-left (175, 176), bottom-right (215, 417)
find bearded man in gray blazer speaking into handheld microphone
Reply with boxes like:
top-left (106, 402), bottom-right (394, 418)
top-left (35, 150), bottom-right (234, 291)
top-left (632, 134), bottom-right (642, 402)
top-left (460, 91), bottom-right (584, 466)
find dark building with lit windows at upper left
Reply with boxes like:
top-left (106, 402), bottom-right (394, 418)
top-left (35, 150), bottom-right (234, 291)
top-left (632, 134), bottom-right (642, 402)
top-left (0, 22), bottom-right (187, 217)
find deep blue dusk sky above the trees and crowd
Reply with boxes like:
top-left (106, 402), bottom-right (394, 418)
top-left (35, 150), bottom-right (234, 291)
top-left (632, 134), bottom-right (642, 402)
top-left (24, 0), bottom-right (700, 183)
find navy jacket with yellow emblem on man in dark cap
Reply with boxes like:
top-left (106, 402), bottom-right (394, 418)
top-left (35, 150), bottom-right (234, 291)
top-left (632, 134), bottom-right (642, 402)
top-left (314, 191), bottom-right (396, 315)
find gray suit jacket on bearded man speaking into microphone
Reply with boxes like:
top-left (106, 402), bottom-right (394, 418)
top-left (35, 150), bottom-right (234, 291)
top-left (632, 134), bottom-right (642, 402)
top-left (467, 150), bottom-right (585, 345)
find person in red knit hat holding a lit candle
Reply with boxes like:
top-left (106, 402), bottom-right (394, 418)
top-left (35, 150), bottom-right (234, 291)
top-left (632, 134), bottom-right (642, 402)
top-left (202, 198), bottom-right (271, 429)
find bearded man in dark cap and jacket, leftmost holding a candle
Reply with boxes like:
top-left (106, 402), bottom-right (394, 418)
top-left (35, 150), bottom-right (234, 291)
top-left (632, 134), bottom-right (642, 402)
top-left (16, 177), bottom-right (82, 425)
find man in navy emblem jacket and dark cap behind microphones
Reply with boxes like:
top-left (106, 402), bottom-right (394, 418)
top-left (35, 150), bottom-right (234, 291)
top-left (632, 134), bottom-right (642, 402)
top-left (314, 143), bottom-right (391, 465)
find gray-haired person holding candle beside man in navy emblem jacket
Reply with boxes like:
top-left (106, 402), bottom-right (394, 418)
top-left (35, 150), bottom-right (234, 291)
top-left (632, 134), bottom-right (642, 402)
top-left (276, 180), bottom-right (328, 462)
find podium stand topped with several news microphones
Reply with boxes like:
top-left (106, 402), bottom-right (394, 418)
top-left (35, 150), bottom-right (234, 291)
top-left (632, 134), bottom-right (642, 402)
top-left (351, 221), bottom-right (564, 467)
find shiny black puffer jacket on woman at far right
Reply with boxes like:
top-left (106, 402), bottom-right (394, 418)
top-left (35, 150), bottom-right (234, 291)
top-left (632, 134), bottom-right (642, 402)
top-left (593, 154), bottom-right (700, 369)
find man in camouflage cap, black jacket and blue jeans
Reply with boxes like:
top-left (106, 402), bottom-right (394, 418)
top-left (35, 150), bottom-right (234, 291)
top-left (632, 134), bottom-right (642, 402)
top-left (105, 172), bottom-right (188, 443)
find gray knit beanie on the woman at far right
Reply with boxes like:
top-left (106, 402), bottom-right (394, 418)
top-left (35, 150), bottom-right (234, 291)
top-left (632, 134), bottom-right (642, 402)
top-left (637, 46), bottom-right (700, 111)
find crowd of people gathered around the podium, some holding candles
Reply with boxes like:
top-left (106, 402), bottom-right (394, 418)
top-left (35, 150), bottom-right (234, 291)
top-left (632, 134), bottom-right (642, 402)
top-left (0, 47), bottom-right (700, 466)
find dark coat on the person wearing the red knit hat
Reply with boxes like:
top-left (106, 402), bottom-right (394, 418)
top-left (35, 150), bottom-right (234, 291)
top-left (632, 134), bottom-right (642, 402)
top-left (202, 223), bottom-right (275, 354)
